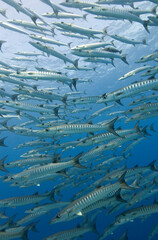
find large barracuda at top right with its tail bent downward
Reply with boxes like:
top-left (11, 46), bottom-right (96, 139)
top-left (84, 6), bottom-right (149, 33)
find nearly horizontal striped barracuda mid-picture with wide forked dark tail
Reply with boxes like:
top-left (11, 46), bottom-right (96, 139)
top-left (36, 117), bottom-right (118, 136)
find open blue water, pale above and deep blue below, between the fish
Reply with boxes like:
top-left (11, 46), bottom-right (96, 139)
top-left (0, 0), bottom-right (158, 240)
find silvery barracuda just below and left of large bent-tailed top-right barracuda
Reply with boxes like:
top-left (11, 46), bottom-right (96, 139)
top-left (54, 22), bottom-right (106, 38)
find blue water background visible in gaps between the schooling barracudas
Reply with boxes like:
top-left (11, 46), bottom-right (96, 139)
top-left (0, 0), bottom-right (158, 240)
